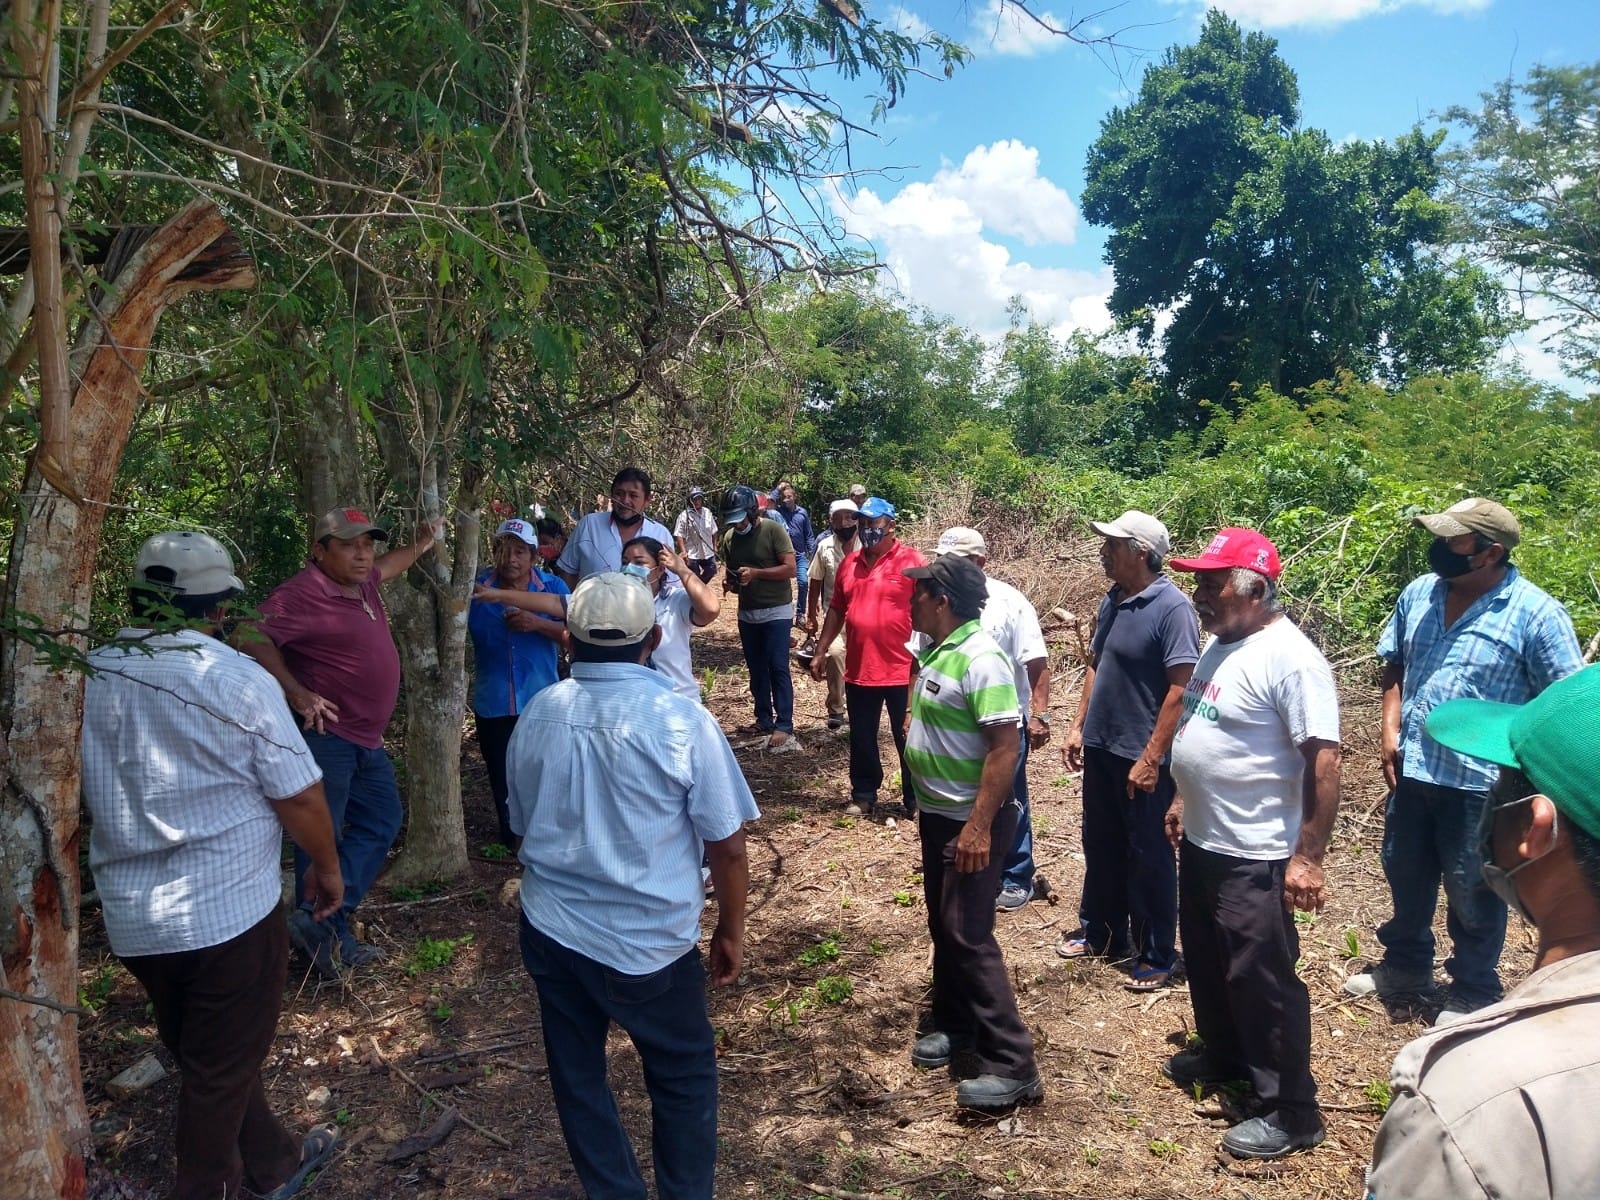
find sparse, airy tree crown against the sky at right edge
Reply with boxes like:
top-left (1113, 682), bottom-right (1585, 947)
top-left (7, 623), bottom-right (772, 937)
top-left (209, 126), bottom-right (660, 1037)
top-left (1445, 62), bottom-right (1600, 379)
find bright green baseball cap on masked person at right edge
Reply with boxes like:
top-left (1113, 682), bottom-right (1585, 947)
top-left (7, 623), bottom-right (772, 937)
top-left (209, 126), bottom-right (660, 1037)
top-left (1422, 664), bottom-right (1600, 838)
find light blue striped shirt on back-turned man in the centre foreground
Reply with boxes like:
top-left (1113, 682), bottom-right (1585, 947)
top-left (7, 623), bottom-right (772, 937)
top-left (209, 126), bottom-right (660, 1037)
top-left (506, 662), bottom-right (760, 974)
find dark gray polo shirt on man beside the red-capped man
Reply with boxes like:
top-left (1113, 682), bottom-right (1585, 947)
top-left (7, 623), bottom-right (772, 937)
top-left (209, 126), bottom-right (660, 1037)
top-left (1083, 574), bottom-right (1200, 758)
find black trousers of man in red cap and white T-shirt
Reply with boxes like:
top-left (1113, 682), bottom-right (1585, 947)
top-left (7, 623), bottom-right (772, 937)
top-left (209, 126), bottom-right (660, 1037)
top-left (1178, 838), bottom-right (1322, 1134)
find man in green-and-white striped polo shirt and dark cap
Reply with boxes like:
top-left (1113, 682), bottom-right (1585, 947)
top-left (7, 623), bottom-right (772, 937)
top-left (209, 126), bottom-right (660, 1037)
top-left (902, 554), bottom-right (1045, 1112)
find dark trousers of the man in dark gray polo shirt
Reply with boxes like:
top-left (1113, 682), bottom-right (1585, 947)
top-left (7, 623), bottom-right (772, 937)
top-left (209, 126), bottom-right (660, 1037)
top-left (1078, 746), bottom-right (1178, 971)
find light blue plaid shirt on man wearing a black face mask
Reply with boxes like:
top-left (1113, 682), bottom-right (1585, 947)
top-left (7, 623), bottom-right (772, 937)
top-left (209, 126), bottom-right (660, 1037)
top-left (1378, 566), bottom-right (1584, 792)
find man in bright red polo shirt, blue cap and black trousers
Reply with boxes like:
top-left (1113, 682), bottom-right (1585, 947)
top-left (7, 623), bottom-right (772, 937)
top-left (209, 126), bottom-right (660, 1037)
top-left (811, 496), bottom-right (926, 816)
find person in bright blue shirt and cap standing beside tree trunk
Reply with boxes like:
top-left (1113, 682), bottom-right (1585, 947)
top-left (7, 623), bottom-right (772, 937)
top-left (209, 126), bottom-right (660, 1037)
top-left (467, 518), bottom-right (566, 850)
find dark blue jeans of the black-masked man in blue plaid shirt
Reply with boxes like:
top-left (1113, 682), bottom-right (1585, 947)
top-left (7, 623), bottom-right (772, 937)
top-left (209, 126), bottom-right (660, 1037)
top-left (1378, 776), bottom-right (1506, 1006)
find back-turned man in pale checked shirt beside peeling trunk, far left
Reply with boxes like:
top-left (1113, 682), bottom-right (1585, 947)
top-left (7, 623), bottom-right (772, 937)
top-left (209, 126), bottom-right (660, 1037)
top-left (83, 531), bottom-right (344, 1200)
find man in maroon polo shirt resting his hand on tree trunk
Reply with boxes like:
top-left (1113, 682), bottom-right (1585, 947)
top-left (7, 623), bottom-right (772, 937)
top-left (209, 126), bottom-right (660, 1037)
top-left (240, 509), bottom-right (443, 978)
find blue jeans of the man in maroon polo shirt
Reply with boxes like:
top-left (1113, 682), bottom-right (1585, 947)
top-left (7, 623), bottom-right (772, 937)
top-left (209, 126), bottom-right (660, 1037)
top-left (294, 730), bottom-right (405, 933)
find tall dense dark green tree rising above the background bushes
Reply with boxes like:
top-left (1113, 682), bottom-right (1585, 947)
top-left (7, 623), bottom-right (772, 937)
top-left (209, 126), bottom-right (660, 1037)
top-left (1083, 11), bottom-right (1504, 424)
